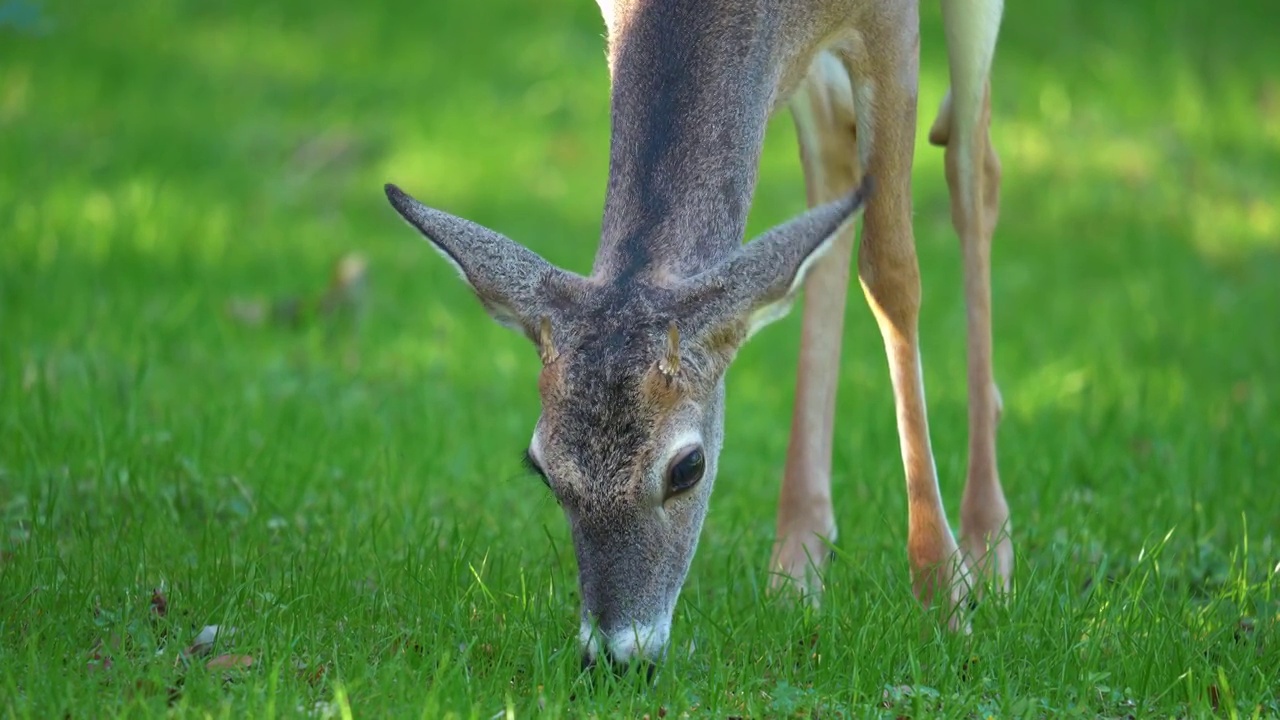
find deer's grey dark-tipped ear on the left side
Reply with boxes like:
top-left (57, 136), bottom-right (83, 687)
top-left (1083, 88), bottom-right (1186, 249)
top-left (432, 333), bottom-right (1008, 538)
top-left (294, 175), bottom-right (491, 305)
top-left (385, 183), bottom-right (576, 342)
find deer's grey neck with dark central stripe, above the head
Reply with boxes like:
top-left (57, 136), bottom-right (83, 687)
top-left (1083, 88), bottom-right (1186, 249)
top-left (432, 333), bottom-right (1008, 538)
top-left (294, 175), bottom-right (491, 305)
top-left (594, 0), bottom-right (778, 281)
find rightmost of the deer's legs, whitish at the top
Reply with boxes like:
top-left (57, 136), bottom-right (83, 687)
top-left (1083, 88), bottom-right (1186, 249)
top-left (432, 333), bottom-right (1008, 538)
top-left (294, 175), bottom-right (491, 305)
top-left (929, 0), bottom-right (1014, 592)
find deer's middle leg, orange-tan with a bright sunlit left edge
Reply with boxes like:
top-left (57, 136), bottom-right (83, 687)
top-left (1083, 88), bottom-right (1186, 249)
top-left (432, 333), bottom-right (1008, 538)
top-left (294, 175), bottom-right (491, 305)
top-left (847, 20), bottom-right (968, 629)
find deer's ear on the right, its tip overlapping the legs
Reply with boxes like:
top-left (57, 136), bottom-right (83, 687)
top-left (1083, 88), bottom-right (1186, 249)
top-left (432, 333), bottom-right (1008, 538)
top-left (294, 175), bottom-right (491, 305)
top-left (682, 177), bottom-right (872, 350)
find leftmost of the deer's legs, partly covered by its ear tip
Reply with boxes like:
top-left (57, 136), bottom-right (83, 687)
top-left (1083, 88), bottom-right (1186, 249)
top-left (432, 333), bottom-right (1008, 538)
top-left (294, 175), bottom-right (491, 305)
top-left (769, 53), bottom-right (861, 602)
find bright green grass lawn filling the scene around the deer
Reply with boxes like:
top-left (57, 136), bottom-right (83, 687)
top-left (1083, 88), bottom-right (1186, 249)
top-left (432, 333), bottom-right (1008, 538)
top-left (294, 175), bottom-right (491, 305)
top-left (0, 0), bottom-right (1280, 719)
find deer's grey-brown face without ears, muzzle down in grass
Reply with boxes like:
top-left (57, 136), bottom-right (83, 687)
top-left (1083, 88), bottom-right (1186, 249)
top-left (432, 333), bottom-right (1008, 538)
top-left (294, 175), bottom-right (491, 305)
top-left (527, 295), bottom-right (724, 664)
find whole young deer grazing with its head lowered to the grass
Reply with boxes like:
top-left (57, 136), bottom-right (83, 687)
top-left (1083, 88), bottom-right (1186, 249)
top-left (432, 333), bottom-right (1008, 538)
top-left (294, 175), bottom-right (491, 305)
top-left (387, 0), bottom-right (1012, 664)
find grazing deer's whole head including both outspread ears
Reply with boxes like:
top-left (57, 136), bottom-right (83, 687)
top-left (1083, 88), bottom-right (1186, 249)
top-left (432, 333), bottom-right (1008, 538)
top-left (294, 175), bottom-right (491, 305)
top-left (387, 176), bottom-right (868, 664)
